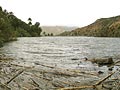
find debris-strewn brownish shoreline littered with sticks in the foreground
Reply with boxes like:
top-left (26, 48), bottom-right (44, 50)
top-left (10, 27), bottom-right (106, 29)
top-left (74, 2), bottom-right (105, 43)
top-left (0, 56), bottom-right (120, 90)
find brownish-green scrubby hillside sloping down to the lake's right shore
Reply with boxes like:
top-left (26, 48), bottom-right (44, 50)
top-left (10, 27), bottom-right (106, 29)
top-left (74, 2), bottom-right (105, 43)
top-left (60, 16), bottom-right (120, 37)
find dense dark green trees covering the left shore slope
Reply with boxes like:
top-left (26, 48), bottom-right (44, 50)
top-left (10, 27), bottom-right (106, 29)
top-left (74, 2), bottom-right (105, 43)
top-left (0, 7), bottom-right (42, 46)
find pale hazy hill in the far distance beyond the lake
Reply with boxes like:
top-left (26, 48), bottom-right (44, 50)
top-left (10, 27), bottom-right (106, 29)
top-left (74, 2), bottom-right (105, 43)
top-left (41, 26), bottom-right (78, 35)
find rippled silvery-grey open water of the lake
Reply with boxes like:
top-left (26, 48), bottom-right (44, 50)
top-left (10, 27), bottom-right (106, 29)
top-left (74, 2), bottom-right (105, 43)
top-left (0, 37), bottom-right (120, 68)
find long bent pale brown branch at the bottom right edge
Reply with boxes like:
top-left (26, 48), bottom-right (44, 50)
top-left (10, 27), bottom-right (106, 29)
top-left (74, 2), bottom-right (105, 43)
top-left (58, 72), bottom-right (115, 90)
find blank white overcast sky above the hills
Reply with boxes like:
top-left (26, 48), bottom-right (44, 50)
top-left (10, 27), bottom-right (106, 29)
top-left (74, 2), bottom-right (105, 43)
top-left (0, 0), bottom-right (120, 27)
